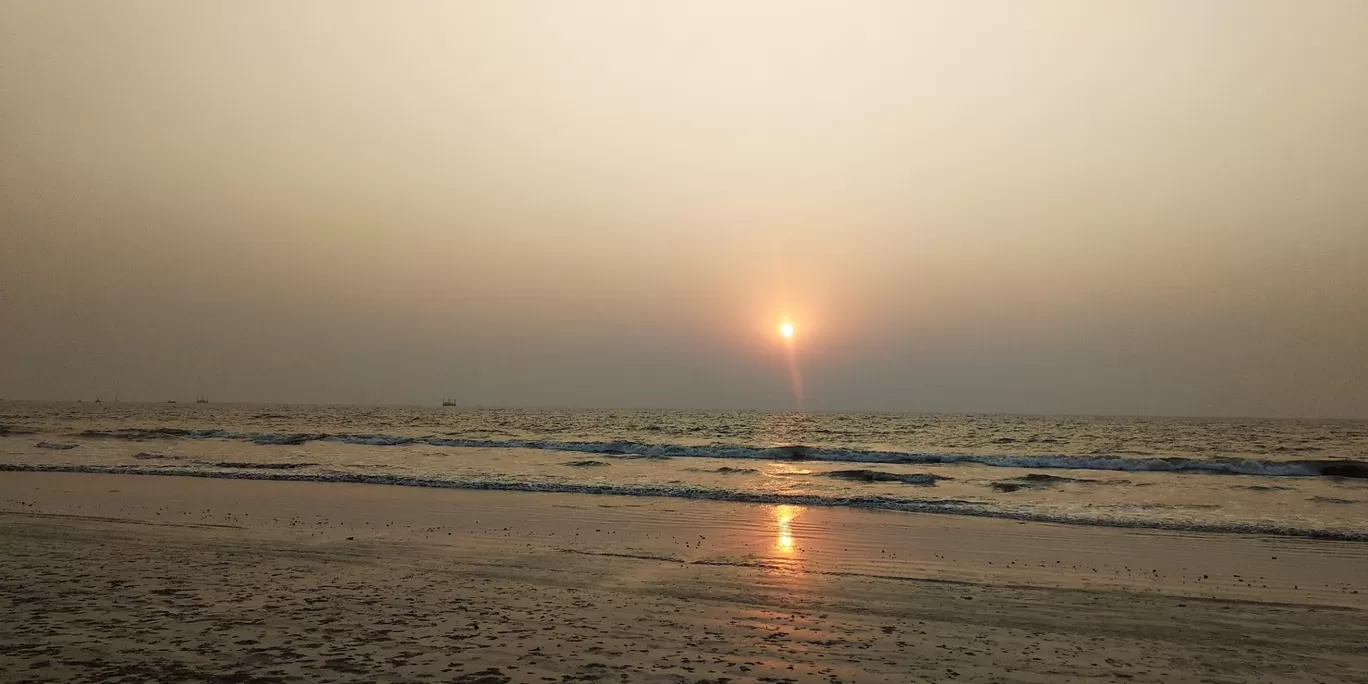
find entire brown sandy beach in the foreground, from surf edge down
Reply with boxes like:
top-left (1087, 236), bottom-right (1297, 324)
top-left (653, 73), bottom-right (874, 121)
top-left (0, 473), bottom-right (1368, 684)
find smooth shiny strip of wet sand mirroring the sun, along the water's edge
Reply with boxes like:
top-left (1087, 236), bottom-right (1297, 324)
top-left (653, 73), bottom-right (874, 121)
top-left (0, 473), bottom-right (1368, 609)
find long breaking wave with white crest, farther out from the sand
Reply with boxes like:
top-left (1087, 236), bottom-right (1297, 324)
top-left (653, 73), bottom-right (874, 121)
top-left (75, 427), bottom-right (1368, 479)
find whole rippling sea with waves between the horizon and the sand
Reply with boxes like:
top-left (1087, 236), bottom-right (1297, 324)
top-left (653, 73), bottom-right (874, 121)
top-left (0, 401), bottom-right (1368, 540)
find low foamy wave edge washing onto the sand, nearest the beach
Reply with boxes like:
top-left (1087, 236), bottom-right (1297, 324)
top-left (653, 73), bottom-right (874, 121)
top-left (0, 464), bottom-right (1368, 542)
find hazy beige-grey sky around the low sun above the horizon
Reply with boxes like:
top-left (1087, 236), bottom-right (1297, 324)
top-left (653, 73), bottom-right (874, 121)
top-left (0, 0), bottom-right (1368, 417)
